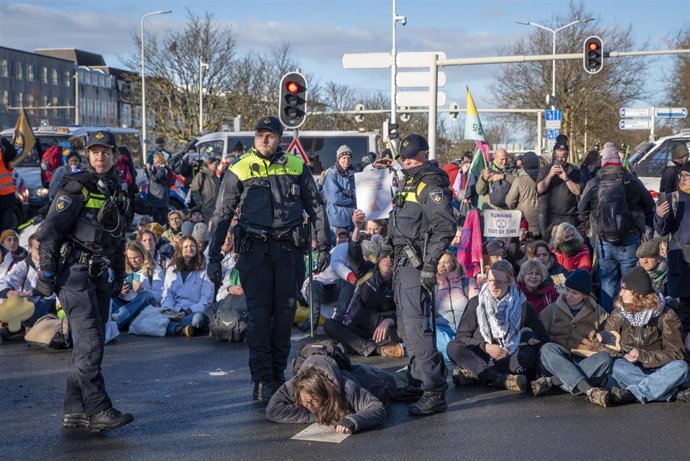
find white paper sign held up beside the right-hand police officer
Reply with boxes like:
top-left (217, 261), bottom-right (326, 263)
top-left (355, 168), bottom-right (393, 220)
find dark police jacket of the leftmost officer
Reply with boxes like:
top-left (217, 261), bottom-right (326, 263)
top-left (40, 170), bottom-right (126, 279)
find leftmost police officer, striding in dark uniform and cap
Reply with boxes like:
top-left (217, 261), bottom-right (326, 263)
top-left (36, 130), bottom-right (133, 431)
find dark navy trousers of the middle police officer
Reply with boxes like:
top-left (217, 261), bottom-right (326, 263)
top-left (236, 240), bottom-right (305, 383)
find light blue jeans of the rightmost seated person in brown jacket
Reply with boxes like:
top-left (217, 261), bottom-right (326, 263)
top-left (611, 358), bottom-right (688, 403)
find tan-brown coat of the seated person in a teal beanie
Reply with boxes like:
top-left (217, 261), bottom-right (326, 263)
top-left (539, 295), bottom-right (608, 355)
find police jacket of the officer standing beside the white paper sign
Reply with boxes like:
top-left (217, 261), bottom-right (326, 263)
top-left (388, 163), bottom-right (456, 267)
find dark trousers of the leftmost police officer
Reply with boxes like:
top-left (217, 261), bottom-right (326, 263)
top-left (56, 264), bottom-right (112, 416)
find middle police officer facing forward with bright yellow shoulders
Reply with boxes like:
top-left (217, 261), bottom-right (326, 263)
top-left (207, 117), bottom-right (331, 401)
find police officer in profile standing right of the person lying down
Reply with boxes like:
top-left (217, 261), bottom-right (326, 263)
top-left (388, 134), bottom-right (455, 415)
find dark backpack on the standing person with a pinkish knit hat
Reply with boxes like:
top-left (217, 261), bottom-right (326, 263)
top-left (597, 174), bottom-right (631, 245)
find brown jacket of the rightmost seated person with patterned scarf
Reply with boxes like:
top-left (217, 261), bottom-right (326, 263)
top-left (594, 296), bottom-right (685, 368)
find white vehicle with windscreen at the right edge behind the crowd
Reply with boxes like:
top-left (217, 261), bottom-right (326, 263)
top-left (630, 130), bottom-right (690, 200)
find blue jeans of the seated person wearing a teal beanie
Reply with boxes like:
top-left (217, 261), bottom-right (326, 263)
top-left (539, 343), bottom-right (611, 394)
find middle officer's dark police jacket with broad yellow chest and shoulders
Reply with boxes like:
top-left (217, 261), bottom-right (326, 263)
top-left (209, 148), bottom-right (330, 262)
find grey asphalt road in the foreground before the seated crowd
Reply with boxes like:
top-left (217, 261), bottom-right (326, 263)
top-left (0, 335), bottom-right (690, 461)
